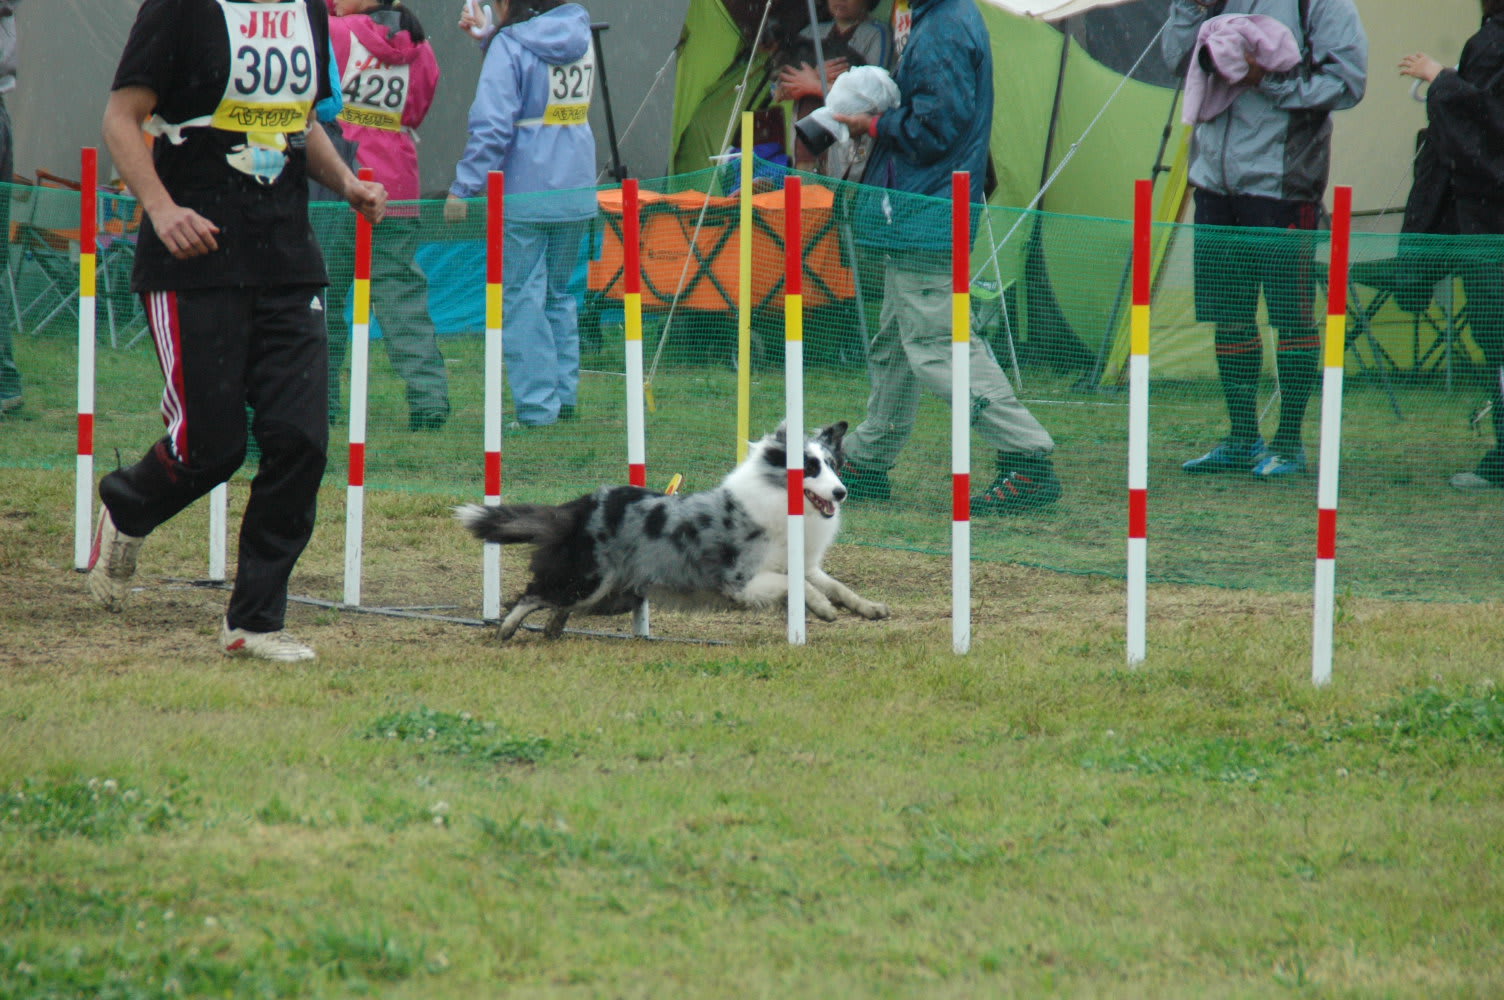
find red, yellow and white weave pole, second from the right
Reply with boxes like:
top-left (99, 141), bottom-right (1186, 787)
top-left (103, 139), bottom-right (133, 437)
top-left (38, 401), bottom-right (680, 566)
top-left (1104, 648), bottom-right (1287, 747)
top-left (1126, 180), bottom-right (1154, 666)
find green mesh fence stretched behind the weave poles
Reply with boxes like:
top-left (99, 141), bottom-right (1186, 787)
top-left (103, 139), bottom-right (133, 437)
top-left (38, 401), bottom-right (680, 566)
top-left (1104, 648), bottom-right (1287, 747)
top-left (0, 164), bottom-right (1504, 603)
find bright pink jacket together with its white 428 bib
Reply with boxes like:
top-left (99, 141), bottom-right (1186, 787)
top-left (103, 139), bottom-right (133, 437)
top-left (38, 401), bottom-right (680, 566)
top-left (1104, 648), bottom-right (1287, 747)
top-left (329, 6), bottom-right (439, 202)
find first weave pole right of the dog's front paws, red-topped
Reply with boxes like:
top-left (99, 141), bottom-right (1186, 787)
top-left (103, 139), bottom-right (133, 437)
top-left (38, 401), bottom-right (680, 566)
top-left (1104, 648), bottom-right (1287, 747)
top-left (951, 170), bottom-right (972, 653)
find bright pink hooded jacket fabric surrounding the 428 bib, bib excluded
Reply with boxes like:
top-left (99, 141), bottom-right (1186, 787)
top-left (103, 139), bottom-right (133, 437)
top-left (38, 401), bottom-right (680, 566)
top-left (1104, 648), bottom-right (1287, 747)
top-left (329, 11), bottom-right (439, 202)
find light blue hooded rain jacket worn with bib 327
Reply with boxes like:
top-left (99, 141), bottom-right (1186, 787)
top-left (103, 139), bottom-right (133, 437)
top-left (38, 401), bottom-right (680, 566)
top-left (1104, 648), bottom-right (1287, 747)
top-left (450, 3), bottom-right (596, 221)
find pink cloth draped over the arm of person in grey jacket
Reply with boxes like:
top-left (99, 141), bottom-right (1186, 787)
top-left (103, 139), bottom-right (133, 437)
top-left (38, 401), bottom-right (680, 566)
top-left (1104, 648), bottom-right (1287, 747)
top-left (1181, 14), bottom-right (1301, 125)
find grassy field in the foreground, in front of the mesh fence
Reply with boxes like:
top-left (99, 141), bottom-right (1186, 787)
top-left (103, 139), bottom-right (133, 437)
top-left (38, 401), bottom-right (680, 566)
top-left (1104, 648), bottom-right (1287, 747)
top-left (0, 457), bottom-right (1504, 1000)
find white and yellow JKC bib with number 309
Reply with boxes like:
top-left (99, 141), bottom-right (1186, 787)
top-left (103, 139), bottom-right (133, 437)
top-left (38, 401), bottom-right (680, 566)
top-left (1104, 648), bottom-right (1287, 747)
top-left (211, 0), bottom-right (319, 132)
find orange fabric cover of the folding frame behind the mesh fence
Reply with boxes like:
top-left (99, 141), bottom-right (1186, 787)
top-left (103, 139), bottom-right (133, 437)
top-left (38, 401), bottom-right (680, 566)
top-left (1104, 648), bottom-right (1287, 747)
top-left (590, 183), bottom-right (856, 310)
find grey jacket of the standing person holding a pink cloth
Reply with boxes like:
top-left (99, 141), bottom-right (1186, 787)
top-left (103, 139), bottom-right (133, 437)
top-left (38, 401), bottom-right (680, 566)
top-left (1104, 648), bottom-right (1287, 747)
top-left (1161, 0), bottom-right (1369, 202)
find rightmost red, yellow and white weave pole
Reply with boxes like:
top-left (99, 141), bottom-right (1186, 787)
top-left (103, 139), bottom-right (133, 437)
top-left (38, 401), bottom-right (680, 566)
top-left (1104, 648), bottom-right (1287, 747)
top-left (1311, 188), bottom-right (1352, 687)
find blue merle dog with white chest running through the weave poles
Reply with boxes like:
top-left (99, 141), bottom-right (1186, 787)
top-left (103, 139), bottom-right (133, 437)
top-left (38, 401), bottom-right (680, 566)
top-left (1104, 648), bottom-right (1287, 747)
top-left (454, 421), bottom-right (887, 639)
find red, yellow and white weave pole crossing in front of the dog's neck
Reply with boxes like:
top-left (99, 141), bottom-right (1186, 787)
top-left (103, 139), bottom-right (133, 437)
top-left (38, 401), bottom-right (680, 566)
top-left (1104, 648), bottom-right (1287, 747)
top-left (784, 174), bottom-right (805, 645)
